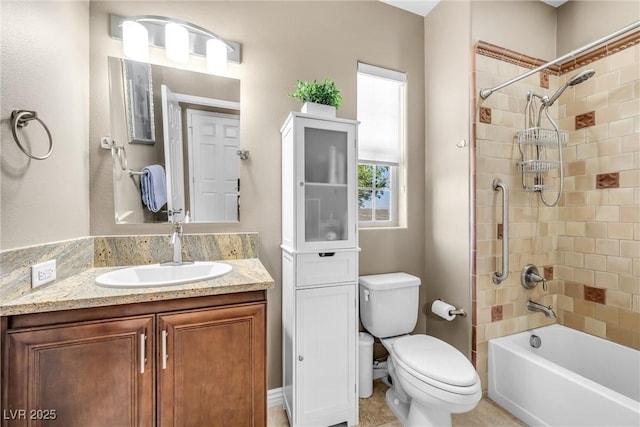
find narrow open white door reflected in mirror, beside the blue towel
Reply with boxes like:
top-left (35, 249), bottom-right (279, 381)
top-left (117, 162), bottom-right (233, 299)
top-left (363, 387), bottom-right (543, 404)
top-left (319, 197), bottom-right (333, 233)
top-left (161, 85), bottom-right (186, 222)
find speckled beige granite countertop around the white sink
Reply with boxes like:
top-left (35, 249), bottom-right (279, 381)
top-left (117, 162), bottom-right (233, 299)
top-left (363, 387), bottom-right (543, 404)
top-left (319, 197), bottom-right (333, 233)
top-left (0, 258), bottom-right (273, 316)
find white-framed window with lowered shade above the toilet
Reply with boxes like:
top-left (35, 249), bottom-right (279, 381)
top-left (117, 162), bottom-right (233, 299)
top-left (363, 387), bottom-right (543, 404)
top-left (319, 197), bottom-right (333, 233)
top-left (357, 63), bottom-right (407, 227)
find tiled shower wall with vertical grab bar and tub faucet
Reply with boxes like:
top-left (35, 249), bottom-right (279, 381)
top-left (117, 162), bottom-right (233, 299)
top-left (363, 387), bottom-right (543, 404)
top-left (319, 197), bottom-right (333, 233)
top-left (472, 46), bottom-right (558, 389)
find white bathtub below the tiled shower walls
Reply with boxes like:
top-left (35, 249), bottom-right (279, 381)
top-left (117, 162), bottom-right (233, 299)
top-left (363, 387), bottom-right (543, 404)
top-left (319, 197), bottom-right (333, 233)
top-left (489, 324), bottom-right (640, 427)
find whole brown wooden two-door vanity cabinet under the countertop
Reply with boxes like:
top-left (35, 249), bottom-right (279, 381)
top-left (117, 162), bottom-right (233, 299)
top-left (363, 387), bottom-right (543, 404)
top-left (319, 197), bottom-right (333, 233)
top-left (1, 291), bottom-right (266, 427)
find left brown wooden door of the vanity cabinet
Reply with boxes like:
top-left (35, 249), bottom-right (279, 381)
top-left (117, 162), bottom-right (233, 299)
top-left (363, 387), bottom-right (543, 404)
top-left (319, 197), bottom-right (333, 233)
top-left (3, 316), bottom-right (155, 427)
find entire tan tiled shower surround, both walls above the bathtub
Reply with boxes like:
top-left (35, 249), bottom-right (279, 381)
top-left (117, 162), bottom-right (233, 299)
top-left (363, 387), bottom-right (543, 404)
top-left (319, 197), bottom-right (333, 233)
top-left (472, 34), bottom-right (640, 389)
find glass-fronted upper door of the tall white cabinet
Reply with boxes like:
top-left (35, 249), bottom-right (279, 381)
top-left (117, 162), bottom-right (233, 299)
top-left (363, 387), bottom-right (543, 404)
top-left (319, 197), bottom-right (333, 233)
top-left (294, 118), bottom-right (356, 250)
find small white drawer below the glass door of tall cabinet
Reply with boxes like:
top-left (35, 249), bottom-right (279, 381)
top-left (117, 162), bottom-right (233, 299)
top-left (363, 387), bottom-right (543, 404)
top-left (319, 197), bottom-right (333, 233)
top-left (296, 252), bottom-right (358, 287)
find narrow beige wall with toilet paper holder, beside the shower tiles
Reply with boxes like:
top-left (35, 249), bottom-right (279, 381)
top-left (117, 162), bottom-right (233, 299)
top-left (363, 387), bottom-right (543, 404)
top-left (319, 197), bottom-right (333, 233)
top-left (424, 1), bottom-right (472, 357)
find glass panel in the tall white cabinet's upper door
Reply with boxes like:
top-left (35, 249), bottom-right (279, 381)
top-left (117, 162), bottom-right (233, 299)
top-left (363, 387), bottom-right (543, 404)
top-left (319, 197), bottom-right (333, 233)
top-left (304, 127), bottom-right (349, 242)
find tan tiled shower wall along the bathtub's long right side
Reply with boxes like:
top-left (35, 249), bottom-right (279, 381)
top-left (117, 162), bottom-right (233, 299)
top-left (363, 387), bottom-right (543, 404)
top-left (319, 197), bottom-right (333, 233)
top-left (555, 40), bottom-right (640, 349)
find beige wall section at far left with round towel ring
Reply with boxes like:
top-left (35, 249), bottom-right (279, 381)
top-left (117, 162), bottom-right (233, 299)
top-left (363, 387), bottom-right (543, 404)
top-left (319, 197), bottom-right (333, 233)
top-left (0, 1), bottom-right (89, 249)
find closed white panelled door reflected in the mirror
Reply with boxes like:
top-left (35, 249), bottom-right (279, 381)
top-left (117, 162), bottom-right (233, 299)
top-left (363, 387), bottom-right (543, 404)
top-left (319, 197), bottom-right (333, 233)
top-left (187, 109), bottom-right (240, 222)
